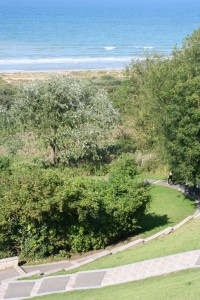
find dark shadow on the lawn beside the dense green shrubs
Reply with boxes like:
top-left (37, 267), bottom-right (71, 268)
top-left (137, 214), bottom-right (170, 234)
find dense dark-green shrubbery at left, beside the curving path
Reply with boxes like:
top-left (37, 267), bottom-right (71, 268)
top-left (0, 157), bottom-right (150, 258)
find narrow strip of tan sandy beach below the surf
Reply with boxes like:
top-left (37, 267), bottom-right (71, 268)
top-left (0, 69), bottom-right (124, 83)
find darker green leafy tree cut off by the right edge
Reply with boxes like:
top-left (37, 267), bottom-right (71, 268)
top-left (163, 29), bottom-right (200, 184)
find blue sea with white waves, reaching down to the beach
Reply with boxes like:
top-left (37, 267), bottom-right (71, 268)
top-left (0, 0), bottom-right (200, 72)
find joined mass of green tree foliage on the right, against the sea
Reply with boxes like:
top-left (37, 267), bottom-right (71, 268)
top-left (117, 29), bottom-right (200, 184)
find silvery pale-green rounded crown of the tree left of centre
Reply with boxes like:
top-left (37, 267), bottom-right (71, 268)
top-left (11, 75), bottom-right (118, 162)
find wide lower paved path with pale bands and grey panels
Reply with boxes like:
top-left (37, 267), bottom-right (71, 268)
top-left (0, 250), bottom-right (200, 299)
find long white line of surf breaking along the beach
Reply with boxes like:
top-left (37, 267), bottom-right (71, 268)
top-left (0, 56), bottom-right (133, 65)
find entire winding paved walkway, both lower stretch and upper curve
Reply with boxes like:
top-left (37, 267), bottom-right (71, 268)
top-left (0, 180), bottom-right (200, 300)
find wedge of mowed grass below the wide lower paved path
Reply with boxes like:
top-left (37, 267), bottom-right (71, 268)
top-left (27, 269), bottom-right (200, 300)
